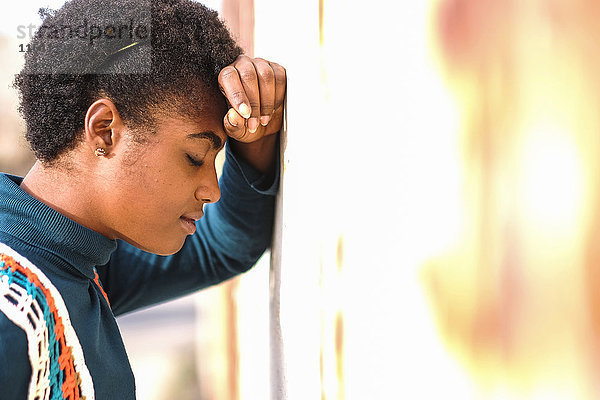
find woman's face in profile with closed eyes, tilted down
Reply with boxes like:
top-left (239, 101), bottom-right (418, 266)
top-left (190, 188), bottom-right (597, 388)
top-left (103, 107), bottom-right (226, 255)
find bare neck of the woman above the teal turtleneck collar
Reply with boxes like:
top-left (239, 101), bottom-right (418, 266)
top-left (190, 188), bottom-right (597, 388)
top-left (21, 161), bottom-right (113, 239)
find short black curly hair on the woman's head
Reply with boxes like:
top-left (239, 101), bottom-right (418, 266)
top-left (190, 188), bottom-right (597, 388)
top-left (14, 0), bottom-right (242, 164)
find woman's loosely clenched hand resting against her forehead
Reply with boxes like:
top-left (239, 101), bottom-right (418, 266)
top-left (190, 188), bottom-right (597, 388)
top-left (219, 55), bottom-right (286, 143)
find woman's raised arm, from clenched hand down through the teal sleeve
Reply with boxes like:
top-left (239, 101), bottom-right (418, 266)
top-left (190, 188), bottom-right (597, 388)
top-left (98, 56), bottom-right (286, 315)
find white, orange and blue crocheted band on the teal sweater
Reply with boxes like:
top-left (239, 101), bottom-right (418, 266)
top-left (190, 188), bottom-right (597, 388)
top-left (0, 243), bottom-right (94, 400)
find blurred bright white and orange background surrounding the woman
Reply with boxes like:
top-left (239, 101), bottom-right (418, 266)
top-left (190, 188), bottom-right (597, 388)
top-left (0, 0), bottom-right (600, 400)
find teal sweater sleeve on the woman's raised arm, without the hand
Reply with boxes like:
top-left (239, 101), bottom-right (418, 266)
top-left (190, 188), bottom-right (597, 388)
top-left (98, 142), bottom-right (278, 315)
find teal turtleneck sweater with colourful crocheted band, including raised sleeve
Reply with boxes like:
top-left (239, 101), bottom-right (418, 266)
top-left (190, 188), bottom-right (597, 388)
top-left (0, 147), bottom-right (278, 400)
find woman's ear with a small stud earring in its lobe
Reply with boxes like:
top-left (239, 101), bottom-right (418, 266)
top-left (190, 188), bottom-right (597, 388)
top-left (84, 98), bottom-right (124, 156)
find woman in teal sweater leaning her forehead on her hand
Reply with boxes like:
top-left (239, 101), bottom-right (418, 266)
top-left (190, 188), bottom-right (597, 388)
top-left (0, 0), bottom-right (286, 400)
